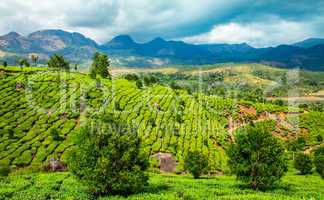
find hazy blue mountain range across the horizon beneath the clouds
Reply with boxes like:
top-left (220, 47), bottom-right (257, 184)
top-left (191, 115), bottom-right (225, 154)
top-left (0, 30), bottom-right (324, 71)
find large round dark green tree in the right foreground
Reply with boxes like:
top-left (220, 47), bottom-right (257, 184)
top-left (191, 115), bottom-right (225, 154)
top-left (227, 122), bottom-right (288, 190)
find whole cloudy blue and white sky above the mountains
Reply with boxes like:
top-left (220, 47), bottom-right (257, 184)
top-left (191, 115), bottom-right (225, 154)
top-left (0, 0), bottom-right (324, 47)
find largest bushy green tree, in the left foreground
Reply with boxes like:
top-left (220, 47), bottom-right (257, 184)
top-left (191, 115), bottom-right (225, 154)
top-left (68, 114), bottom-right (148, 195)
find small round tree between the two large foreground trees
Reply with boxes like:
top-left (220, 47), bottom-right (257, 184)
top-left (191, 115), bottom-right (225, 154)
top-left (184, 151), bottom-right (208, 179)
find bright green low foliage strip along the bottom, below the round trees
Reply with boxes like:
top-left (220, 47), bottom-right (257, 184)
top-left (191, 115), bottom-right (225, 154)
top-left (0, 169), bottom-right (324, 200)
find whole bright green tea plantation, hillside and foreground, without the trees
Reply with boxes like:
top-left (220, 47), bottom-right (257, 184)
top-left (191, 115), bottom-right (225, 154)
top-left (0, 68), bottom-right (324, 199)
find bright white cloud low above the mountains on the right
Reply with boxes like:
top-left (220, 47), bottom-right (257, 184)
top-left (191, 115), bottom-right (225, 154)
top-left (183, 20), bottom-right (315, 47)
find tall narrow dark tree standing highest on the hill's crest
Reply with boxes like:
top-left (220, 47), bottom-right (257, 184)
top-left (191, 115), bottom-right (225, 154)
top-left (90, 52), bottom-right (111, 79)
